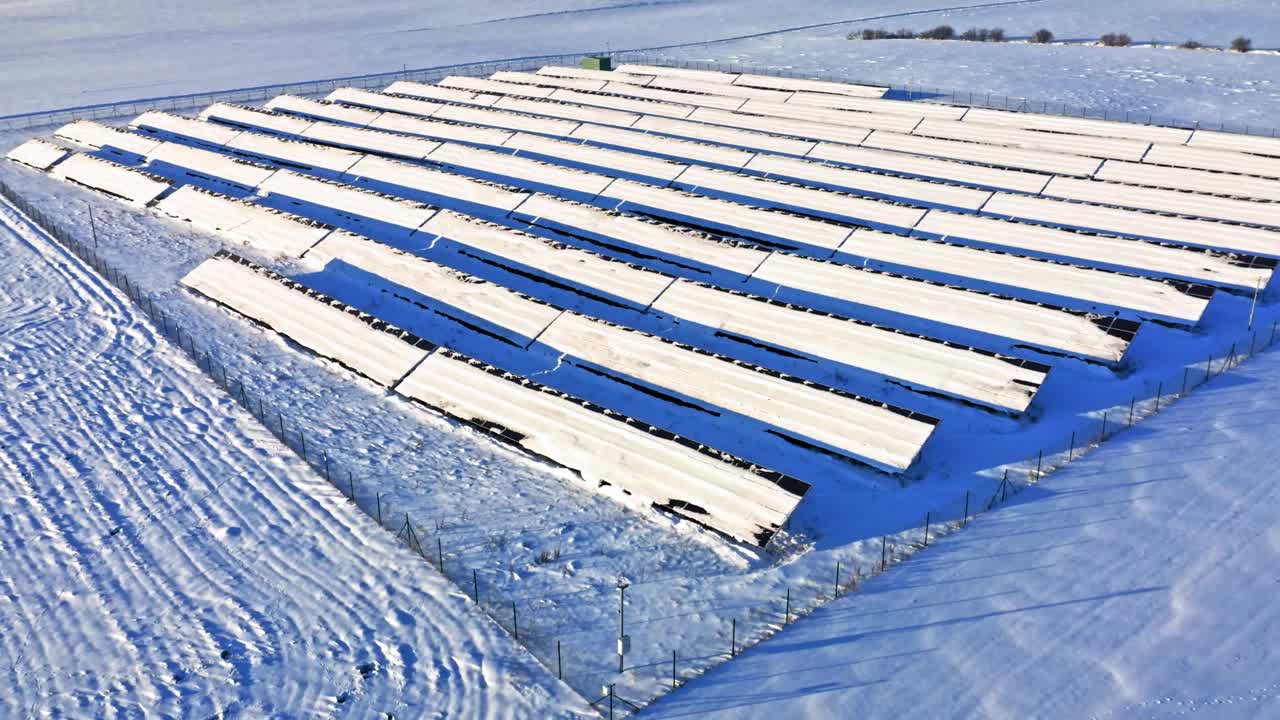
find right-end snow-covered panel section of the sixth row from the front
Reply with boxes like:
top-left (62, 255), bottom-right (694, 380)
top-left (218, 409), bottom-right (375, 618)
top-left (915, 211), bottom-right (1271, 287)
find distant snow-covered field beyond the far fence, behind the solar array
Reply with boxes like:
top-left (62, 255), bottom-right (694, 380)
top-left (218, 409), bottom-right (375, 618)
top-left (0, 0), bottom-right (1280, 127)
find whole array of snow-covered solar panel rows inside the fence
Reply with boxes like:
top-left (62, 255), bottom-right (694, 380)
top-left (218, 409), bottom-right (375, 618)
top-left (8, 65), bottom-right (1280, 544)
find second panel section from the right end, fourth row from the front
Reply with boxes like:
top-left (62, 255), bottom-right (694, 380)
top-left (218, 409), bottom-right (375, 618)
top-left (515, 195), bottom-right (768, 275)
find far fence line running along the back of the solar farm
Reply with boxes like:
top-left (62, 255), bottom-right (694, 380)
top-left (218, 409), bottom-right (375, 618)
top-left (0, 51), bottom-right (1280, 137)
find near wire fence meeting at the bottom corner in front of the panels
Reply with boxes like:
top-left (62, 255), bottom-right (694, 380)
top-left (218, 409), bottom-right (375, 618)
top-left (0, 172), bottom-right (1277, 716)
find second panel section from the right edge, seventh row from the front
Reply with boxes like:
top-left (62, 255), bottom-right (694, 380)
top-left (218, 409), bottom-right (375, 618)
top-left (746, 155), bottom-right (991, 210)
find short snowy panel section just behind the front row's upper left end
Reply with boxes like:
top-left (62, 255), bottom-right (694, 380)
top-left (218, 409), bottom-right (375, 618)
top-left (156, 186), bottom-right (332, 258)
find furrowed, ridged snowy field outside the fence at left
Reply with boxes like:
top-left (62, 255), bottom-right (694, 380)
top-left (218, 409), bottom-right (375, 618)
top-left (0, 194), bottom-right (582, 719)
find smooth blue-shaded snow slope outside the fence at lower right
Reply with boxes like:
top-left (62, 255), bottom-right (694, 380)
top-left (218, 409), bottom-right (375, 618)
top-left (645, 352), bottom-right (1280, 720)
